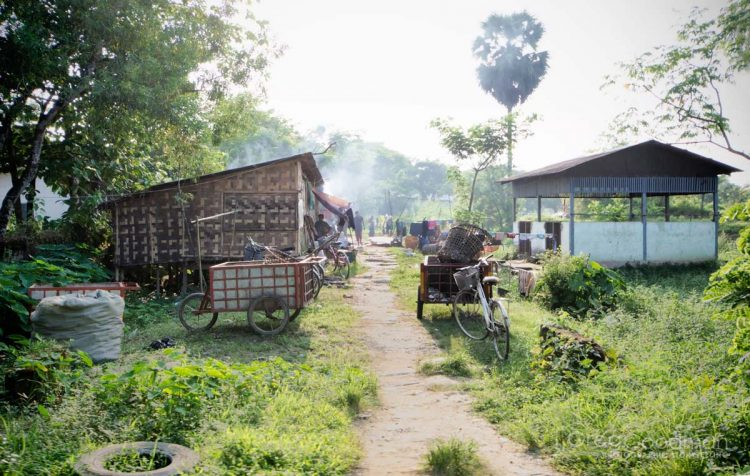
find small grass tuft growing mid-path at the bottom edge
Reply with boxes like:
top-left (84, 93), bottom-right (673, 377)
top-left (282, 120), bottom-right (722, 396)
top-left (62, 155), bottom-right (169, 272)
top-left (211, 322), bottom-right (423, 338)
top-left (424, 438), bottom-right (484, 476)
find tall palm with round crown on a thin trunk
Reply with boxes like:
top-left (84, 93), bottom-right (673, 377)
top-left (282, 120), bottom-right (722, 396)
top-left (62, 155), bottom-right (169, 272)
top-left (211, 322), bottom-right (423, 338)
top-left (474, 11), bottom-right (549, 173)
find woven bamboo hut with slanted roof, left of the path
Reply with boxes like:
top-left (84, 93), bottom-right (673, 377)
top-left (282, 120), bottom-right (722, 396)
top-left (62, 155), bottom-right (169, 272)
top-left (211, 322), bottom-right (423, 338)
top-left (107, 153), bottom-right (323, 269)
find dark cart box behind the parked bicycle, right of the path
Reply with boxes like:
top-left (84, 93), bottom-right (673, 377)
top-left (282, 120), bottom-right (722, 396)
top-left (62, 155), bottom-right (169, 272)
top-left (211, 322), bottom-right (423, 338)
top-left (417, 256), bottom-right (492, 319)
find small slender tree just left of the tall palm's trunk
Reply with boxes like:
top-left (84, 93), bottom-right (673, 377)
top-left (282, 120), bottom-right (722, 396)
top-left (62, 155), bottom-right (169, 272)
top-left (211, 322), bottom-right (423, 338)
top-left (431, 119), bottom-right (508, 213)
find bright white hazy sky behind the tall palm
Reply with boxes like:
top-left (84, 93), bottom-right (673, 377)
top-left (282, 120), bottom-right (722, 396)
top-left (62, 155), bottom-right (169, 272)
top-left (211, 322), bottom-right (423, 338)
top-left (255, 0), bottom-right (750, 184)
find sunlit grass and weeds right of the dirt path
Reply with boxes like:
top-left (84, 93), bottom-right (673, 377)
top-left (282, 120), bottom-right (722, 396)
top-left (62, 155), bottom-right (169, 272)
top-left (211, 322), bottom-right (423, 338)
top-left (391, 250), bottom-right (750, 475)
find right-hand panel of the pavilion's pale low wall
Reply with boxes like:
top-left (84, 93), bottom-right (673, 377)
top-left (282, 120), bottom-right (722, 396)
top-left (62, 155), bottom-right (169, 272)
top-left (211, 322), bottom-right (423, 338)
top-left (648, 221), bottom-right (716, 263)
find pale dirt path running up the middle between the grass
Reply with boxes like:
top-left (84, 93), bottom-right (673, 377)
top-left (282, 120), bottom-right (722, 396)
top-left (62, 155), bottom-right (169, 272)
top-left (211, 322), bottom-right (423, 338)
top-left (353, 247), bottom-right (558, 476)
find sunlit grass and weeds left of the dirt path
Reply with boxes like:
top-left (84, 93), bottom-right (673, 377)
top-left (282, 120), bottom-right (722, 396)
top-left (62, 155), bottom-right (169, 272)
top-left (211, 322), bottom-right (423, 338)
top-left (0, 278), bottom-right (377, 475)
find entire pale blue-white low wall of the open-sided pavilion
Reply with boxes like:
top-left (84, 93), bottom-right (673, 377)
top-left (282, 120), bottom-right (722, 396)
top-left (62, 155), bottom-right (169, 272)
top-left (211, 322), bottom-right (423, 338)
top-left (562, 221), bottom-right (716, 266)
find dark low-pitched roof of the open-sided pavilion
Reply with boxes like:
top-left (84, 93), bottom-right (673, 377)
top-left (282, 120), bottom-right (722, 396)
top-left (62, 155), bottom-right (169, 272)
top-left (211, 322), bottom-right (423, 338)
top-left (499, 140), bottom-right (740, 183)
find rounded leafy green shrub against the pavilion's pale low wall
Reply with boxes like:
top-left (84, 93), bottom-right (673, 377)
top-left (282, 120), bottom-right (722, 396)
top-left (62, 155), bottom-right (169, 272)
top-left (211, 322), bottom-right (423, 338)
top-left (535, 253), bottom-right (625, 319)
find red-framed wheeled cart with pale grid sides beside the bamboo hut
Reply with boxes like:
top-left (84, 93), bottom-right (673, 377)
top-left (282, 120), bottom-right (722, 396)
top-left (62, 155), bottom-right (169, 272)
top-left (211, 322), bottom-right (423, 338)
top-left (178, 257), bottom-right (320, 336)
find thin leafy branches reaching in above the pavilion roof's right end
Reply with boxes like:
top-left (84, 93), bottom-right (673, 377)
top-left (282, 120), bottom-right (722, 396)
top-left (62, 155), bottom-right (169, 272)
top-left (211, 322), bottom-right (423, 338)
top-left (605, 0), bottom-right (750, 159)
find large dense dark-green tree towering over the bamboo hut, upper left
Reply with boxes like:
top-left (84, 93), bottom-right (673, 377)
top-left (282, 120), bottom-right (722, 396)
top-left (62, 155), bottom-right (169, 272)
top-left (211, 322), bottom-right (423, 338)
top-left (0, 0), bottom-right (274, 242)
